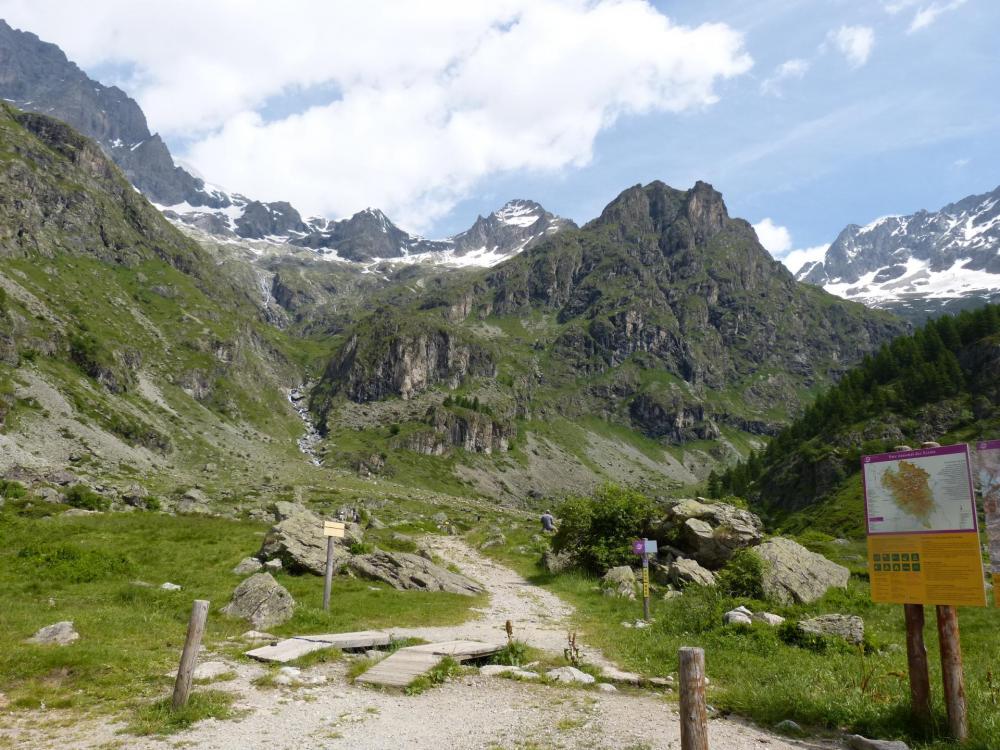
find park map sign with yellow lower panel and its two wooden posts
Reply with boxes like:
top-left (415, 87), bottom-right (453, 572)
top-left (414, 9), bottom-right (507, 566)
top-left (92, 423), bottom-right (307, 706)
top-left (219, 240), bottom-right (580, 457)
top-left (861, 443), bottom-right (986, 740)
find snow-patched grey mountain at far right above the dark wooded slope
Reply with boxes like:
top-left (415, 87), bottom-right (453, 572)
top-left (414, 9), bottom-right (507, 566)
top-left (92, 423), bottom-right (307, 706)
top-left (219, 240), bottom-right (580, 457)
top-left (796, 187), bottom-right (1000, 319)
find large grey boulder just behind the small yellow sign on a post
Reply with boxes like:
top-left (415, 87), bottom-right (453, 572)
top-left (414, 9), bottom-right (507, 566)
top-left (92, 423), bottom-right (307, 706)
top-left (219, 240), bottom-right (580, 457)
top-left (257, 503), bottom-right (363, 575)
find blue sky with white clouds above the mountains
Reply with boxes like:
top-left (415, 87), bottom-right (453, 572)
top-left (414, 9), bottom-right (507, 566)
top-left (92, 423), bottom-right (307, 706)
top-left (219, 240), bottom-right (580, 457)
top-left (0, 0), bottom-right (1000, 271)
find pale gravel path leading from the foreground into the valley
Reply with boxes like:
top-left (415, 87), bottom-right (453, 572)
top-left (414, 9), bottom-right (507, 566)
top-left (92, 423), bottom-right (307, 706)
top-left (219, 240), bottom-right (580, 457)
top-left (0, 538), bottom-right (821, 750)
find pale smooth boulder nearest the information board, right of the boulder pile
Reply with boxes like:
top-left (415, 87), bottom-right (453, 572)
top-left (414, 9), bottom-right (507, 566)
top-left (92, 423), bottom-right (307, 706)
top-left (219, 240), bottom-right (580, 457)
top-left (751, 537), bottom-right (851, 604)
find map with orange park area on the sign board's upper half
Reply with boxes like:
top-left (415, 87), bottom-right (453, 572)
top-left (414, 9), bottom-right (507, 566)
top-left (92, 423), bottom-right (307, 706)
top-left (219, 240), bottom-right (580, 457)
top-left (864, 445), bottom-right (976, 534)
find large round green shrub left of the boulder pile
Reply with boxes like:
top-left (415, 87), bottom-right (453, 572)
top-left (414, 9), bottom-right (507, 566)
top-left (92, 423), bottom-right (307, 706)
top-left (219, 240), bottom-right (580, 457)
top-left (552, 484), bottom-right (656, 573)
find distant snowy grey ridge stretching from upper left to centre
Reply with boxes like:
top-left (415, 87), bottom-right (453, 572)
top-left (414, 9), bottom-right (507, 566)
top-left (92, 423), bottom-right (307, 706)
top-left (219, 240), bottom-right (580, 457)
top-left (0, 20), bottom-right (573, 266)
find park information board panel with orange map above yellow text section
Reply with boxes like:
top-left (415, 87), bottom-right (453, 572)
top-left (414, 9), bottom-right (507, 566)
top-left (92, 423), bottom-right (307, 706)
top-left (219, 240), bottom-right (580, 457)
top-left (861, 444), bottom-right (986, 607)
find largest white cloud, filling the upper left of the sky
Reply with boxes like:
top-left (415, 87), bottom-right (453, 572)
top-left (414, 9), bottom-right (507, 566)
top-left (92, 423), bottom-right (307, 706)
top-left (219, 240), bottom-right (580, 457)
top-left (0, 0), bottom-right (752, 230)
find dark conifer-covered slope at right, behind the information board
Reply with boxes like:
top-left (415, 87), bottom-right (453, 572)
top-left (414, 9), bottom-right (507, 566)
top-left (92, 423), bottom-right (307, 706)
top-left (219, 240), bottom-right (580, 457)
top-left (710, 305), bottom-right (1000, 536)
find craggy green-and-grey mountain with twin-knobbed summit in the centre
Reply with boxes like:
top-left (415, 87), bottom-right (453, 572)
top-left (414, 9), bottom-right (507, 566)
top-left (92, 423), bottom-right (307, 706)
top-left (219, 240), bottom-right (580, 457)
top-left (312, 183), bottom-right (904, 494)
